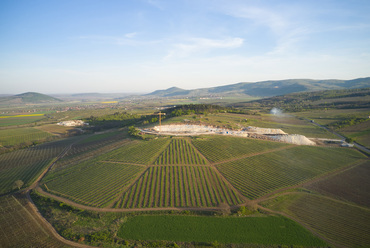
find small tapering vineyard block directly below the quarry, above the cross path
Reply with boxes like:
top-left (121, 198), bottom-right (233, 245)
top-left (154, 139), bottom-right (206, 165)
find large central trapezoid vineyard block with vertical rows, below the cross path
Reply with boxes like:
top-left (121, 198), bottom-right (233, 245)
top-left (116, 166), bottom-right (241, 208)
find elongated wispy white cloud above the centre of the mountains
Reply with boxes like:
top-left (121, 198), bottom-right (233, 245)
top-left (165, 37), bottom-right (244, 59)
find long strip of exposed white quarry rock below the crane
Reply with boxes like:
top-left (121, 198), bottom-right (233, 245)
top-left (141, 124), bottom-right (316, 145)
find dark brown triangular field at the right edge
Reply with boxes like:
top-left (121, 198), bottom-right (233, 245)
top-left (306, 161), bottom-right (370, 208)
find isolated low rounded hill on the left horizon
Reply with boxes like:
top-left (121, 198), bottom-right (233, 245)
top-left (0, 92), bottom-right (62, 104)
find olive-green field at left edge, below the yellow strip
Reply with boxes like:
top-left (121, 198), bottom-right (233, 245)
top-left (0, 127), bottom-right (53, 146)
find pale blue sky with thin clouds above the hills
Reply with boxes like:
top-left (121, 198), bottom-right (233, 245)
top-left (0, 0), bottom-right (370, 94)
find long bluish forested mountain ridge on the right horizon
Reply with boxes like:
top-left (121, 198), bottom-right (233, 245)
top-left (146, 77), bottom-right (370, 97)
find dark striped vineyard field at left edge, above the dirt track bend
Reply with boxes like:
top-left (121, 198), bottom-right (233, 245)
top-left (0, 139), bottom-right (73, 194)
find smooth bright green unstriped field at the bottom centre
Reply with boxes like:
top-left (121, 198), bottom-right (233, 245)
top-left (118, 215), bottom-right (327, 247)
